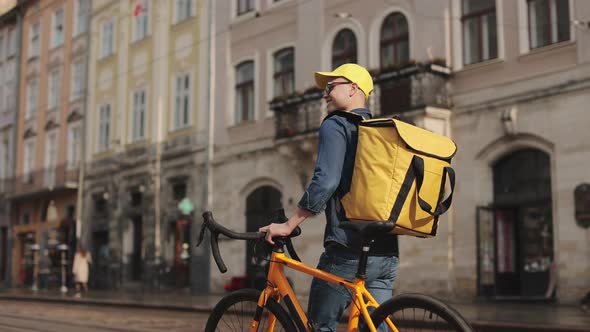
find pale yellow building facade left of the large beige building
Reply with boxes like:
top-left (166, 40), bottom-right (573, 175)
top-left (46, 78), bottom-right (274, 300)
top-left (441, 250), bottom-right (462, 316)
top-left (82, 0), bottom-right (208, 288)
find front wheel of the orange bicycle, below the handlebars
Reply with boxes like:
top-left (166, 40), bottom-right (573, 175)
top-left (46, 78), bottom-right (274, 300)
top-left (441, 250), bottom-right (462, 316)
top-left (205, 289), bottom-right (297, 332)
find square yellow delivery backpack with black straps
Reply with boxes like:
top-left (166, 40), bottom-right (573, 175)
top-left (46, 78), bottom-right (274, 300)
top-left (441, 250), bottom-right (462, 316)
top-left (341, 116), bottom-right (457, 237)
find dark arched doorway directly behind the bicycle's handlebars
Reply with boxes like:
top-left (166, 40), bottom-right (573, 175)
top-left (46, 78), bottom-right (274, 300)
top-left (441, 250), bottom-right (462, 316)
top-left (246, 186), bottom-right (283, 288)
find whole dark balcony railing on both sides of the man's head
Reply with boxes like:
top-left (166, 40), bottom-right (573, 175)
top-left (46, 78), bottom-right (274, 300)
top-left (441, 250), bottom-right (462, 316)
top-left (270, 63), bottom-right (451, 139)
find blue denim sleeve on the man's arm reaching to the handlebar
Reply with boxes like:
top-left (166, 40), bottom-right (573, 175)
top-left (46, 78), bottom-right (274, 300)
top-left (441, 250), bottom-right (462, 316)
top-left (297, 119), bottom-right (346, 214)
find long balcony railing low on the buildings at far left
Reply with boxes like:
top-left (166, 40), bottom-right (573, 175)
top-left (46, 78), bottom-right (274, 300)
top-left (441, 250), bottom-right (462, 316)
top-left (3, 165), bottom-right (78, 196)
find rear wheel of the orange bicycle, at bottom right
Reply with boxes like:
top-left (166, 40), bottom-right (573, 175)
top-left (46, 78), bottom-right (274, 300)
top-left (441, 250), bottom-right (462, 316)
top-left (365, 294), bottom-right (473, 332)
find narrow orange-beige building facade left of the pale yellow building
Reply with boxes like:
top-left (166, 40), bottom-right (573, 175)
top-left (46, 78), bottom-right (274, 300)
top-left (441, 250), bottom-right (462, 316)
top-left (9, 0), bottom-right (89, 286)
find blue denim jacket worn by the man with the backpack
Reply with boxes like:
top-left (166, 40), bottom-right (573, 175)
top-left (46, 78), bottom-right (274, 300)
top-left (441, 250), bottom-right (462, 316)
top-left (298, 108), bottom-right (398, 256)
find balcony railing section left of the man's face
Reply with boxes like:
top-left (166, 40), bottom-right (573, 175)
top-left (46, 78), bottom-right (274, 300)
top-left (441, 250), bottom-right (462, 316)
top-left (270, 89), bottom-right (323, 139)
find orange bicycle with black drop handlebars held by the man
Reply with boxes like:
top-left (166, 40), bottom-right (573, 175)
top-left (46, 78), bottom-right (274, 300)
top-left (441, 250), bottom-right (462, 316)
top-left (197, 211), bottom-right (472, 332)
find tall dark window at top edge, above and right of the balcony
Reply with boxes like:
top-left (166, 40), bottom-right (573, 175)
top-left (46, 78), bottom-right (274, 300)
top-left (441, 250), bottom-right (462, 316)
top-left (461, 0), bottom-right (498, 65)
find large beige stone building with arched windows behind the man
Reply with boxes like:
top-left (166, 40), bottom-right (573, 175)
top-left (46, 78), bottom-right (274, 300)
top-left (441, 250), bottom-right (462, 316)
top-left (205, 0), bottom-right (590, 303)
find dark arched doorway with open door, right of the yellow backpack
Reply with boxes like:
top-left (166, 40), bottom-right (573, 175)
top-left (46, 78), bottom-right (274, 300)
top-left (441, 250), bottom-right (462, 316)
top-left (477, 149), bottom-right (555, 299)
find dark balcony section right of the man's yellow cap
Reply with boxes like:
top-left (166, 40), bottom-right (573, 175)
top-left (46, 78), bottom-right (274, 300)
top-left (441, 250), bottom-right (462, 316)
top-left (371, 63), bottom-right (451, 116)
